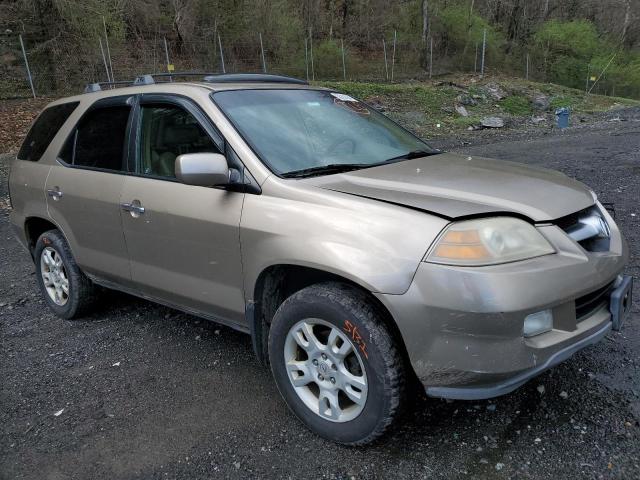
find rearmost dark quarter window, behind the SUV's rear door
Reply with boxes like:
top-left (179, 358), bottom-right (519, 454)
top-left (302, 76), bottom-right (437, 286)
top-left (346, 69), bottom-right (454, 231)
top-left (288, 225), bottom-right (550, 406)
top-left (18, 102), bottom-right (80, 162)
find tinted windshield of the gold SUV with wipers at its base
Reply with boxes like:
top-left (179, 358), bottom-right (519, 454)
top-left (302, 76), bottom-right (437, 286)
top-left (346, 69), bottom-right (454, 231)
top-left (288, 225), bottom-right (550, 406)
top-left (213, 89), bottom-right (438, 176)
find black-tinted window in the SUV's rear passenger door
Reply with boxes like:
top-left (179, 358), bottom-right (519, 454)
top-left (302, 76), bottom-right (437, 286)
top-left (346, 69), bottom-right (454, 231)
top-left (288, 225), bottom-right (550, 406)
top-left (60, 105), bottom-right (131, 171)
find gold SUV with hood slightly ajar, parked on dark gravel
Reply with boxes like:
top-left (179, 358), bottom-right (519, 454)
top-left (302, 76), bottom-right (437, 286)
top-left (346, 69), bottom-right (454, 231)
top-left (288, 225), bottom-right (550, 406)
top-left (9, 74), bottom-right (632, 445)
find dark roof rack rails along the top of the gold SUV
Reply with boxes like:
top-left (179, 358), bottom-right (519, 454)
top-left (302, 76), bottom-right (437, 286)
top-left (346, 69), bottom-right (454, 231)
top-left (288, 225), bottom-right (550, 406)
top-left (84, 72), bottom-right (309, 93)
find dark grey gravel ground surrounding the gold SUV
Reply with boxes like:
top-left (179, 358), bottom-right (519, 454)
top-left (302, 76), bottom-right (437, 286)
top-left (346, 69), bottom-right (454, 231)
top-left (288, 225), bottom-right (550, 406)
top-left (0, 109), bottom-right (640, 479)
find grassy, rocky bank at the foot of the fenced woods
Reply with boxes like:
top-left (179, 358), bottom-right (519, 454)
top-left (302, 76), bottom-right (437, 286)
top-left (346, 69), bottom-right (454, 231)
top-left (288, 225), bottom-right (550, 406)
top-left (0, 75), bottom-right (640, 153)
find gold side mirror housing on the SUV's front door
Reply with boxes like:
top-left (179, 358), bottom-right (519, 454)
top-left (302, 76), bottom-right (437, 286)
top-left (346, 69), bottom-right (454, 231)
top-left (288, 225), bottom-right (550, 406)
top-left (175, 153), bottom-right (231, 187)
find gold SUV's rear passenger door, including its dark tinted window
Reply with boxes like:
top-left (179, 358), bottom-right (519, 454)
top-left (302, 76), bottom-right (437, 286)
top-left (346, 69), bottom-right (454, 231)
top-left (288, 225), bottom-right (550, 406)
top-left (45, 96), bottom-right (135, 285)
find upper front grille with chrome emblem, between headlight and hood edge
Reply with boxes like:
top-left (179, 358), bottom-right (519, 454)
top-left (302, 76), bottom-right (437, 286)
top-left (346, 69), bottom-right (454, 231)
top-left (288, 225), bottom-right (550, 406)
top-left (554, 205), bottom-right (610, 252)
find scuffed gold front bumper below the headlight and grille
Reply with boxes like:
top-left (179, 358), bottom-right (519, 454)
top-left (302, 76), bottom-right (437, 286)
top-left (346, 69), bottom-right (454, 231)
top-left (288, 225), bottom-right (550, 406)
top-left (378, 222), bottom-right (628, 399)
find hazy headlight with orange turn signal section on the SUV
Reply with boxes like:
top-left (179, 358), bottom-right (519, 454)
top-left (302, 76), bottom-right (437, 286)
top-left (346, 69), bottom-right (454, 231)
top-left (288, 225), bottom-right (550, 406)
top-left (426, 217), bottom-right (555, 266)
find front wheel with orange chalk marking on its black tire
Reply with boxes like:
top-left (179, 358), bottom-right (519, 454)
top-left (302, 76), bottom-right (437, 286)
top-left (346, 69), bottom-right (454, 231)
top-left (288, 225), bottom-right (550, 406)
top-left (269, 282), bottom-right (405, 445)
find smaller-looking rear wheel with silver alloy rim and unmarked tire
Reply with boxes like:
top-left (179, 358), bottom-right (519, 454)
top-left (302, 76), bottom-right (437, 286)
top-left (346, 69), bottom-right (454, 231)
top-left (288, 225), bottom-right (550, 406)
top-left (34, 230), bottom-right (97, 320)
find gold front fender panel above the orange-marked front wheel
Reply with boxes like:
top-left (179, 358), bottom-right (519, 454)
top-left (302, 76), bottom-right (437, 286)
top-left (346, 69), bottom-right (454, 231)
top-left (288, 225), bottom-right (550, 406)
top-left (240, 180), bottom-right (447, 300)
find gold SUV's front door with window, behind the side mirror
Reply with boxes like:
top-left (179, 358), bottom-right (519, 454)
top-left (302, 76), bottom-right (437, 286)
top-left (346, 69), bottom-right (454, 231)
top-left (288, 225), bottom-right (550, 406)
top-left (120, 95), bottom-right (244, 323)
